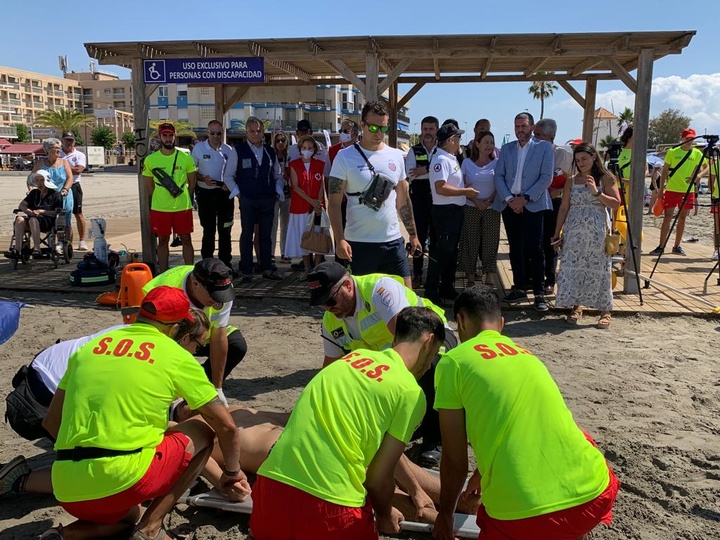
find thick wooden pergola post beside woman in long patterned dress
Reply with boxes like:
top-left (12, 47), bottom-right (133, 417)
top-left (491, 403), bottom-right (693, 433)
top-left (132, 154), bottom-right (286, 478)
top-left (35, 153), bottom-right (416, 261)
top-left (623, 49), bottom-right (655, 294)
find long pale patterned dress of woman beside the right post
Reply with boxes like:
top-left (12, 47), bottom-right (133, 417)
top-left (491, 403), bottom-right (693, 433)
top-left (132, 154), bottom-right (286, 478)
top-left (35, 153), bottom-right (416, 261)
top-left (555, 184), bottom-right (612, 311)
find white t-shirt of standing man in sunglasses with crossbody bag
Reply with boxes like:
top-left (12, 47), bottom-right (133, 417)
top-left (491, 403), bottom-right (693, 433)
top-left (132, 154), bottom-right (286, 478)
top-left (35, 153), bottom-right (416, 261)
top-left (330, 144), bottom-right (406, 244)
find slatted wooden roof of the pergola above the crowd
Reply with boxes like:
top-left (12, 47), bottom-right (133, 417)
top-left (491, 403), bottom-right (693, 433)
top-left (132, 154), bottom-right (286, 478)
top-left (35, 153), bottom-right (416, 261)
top-left (85, 30), bottom-right (695, 84)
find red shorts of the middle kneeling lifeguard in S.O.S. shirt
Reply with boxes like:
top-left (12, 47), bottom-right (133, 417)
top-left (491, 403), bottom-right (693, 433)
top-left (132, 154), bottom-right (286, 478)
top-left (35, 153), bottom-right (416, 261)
top-left (250, 476), bottom-right (378, 540)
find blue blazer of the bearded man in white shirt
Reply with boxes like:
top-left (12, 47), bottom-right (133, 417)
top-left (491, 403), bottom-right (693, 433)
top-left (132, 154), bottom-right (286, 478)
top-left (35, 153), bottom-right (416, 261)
top-left (493, 137), bottom-right (554, 212)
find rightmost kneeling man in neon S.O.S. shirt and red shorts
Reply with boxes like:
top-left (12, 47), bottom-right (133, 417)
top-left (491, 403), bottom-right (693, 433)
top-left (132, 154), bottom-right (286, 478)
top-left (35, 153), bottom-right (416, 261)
top-left (433, 285), bottom-right (620, 540)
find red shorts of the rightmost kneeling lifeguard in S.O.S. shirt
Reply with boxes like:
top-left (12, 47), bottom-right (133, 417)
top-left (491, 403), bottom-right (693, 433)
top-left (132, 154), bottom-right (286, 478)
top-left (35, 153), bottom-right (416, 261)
top-left (477, 430), bottom-right (620, 540)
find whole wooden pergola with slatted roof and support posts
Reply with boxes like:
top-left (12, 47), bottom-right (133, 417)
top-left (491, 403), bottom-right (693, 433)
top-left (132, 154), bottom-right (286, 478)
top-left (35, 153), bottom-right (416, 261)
top-left (85, 30), bottom-right (695, 292)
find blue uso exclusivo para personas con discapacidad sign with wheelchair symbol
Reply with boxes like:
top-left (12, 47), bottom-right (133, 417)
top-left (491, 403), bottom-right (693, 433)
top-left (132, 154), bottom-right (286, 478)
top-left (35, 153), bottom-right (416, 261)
top-left (143, 56), bottom-right (265, 84)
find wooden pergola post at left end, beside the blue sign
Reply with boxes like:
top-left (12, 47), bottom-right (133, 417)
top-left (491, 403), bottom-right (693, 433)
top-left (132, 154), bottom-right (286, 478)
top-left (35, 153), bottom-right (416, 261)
top-left (132, 58), bottom-right (157, 273)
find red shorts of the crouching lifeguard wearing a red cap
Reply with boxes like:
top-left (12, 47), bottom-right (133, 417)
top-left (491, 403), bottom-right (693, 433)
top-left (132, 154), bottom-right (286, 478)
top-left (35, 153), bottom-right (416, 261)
top-left (60, 431), bottom-right (192, 523)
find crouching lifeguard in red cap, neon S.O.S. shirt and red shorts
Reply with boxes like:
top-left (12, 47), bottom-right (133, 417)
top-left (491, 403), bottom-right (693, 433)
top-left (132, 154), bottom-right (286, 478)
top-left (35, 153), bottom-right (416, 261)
top-left (42, 287), bottom-right (250, 540)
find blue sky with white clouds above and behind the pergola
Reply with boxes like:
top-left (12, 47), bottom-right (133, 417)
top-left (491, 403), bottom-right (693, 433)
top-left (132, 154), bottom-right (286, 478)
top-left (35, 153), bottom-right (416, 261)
top-left (0, 0), bottom-right (720, 143)
